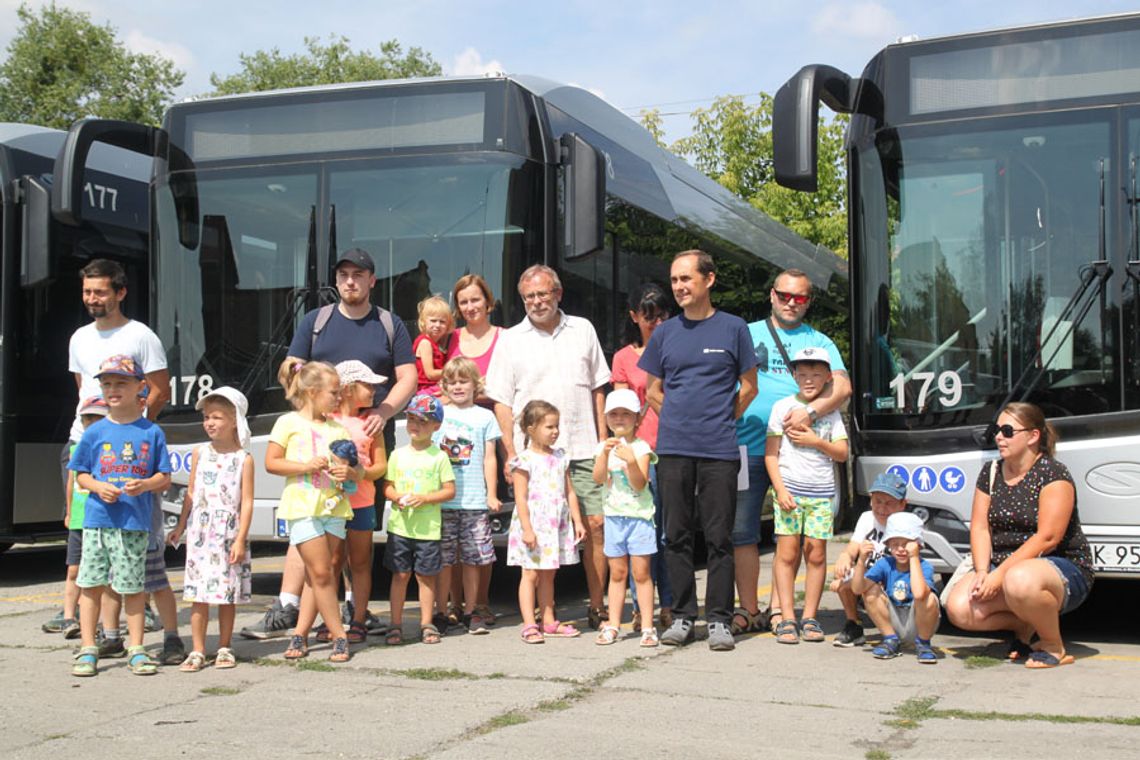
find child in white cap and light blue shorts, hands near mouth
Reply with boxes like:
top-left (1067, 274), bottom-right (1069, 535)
top-left (594, 389), bottom-right (659, 646)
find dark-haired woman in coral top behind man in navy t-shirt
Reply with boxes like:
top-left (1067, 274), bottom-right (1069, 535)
top-left (612, 283), bottom-right (673, 630)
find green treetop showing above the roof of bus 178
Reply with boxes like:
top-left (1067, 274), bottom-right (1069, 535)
top-left (210, 36), bottom-right (443, 96)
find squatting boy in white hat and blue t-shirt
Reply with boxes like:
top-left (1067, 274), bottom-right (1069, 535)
top-left (852, 512), bottom-right (942, 665)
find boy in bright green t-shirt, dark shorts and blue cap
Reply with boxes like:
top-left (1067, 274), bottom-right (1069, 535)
top-left (384, 394), bottom-right (455, 644)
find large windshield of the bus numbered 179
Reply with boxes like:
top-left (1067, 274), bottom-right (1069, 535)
top-left (852, 112), bottom-right (1121, 427)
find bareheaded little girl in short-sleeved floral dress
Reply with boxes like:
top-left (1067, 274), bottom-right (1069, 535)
top-left (506, 400), bottom-right (586, 644)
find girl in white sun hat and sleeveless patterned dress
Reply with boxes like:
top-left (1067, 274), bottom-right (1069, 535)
top-left (168, 387), bottom-right (253, 672)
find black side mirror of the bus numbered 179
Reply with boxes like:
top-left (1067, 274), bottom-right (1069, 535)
top-left (772, 64), bottom-right (854, 193)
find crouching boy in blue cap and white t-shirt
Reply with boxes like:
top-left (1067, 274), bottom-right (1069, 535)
top-left (831, 472), bottom-right (906, 646)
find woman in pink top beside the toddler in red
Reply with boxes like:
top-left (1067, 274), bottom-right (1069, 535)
top-left (447, 275), bottom-right (503, 626)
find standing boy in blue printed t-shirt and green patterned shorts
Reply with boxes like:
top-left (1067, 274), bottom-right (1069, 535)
top-left (67, 354), bottom-right (170, 676)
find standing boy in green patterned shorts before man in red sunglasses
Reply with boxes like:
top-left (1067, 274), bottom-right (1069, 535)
top-left (764, 348), bottom-right (847, 644)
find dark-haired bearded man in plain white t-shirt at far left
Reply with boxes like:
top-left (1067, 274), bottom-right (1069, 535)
top-left (60, 259), bottom-right (186, 664)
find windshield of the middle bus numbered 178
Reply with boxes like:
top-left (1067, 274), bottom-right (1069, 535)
top-left (155, 153), bottom-right (542, 414)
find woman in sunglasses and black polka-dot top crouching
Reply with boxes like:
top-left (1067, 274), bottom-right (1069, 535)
top-left (945, 403), bottom-right (1093, 668)
